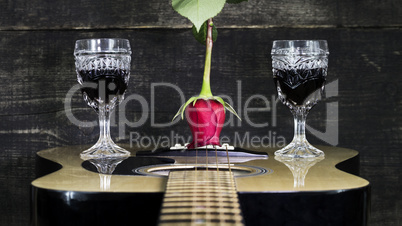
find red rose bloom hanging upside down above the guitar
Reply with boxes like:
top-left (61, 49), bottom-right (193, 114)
top-left (185, 99), bottom-right (225, 148)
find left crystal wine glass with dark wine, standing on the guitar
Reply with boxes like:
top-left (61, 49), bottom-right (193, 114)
top-left (74, 38), bottom-right (131, 159)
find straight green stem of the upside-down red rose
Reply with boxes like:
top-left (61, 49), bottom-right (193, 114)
top-left (200, 18), bottom-right (213, 97)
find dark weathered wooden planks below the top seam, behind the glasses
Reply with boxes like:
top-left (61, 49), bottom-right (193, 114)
top-left (0, 28), bottom-right (402, 225)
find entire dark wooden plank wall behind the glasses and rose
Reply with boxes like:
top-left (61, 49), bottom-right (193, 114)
top-left (0, 0), bottom-right (402, 225)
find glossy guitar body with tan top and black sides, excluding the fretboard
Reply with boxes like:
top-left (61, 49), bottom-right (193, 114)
top-left (31, 146), bottom-right (370, 226)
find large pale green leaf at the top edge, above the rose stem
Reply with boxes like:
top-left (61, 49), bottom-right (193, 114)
top-left (172, 0), bottom-right (226, 32)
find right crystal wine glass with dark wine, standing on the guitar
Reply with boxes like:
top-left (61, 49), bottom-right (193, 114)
top-left (271, 40), bottom-right (329, 158)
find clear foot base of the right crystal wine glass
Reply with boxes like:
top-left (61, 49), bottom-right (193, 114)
top-left (275, 142), bottom-right (324, 158)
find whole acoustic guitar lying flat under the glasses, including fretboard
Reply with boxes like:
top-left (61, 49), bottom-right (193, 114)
top-left (31, 145), bottom-right (370, 226)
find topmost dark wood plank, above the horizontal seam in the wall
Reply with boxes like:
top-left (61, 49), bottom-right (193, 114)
top-left (0, 0), bottom-right (402, 30)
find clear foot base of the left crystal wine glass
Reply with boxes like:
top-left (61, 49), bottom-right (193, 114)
top-left (80, 141), bottom-right (131, 160)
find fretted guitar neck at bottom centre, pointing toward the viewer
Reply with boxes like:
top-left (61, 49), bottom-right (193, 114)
top-left (159, 170), bottom-right (243, 226)
